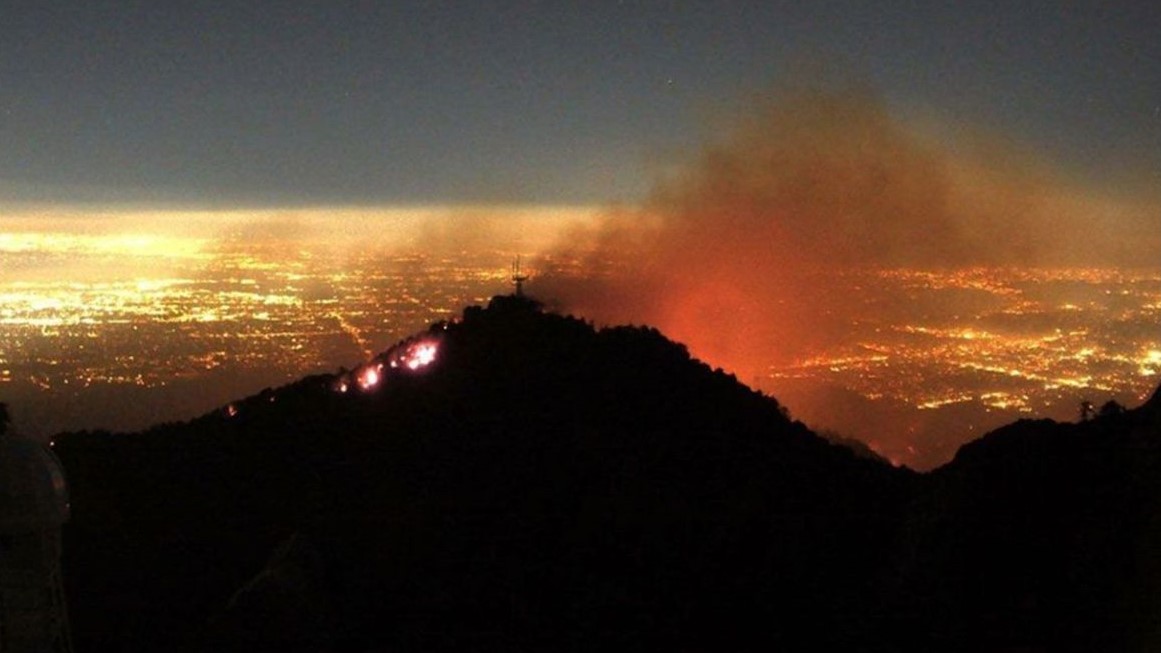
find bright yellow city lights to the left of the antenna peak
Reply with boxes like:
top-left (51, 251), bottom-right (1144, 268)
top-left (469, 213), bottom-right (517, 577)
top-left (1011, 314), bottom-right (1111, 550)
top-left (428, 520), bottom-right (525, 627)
top-left (0, 244), bottom-right (507, 390)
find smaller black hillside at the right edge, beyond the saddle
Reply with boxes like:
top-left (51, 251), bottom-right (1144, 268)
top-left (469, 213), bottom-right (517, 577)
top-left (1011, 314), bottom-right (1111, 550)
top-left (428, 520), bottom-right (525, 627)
top-left (900, 395), bottom-right (1161, 651)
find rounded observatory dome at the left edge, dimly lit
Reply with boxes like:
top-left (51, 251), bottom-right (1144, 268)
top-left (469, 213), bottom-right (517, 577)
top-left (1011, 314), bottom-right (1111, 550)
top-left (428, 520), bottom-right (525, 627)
top-left (0, 436), bottom-right (68, 534)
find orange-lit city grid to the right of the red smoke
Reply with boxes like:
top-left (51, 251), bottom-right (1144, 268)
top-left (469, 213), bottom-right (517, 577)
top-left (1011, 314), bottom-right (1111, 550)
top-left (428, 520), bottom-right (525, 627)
top-left (770, 268), bottom-right (1161, 414)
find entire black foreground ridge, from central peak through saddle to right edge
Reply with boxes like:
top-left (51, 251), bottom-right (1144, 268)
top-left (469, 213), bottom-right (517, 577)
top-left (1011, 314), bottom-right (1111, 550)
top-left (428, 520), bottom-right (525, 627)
top-left (49, 297), bottom-right (1161, 651)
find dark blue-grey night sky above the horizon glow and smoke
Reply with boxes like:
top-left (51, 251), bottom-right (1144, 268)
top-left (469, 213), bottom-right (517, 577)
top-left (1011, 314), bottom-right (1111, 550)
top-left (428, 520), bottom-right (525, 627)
top-left (0, 0), bottom-right (1161, 204)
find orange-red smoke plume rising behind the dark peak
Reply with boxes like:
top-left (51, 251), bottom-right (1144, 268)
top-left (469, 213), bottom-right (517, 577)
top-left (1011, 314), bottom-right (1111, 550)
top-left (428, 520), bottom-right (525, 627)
top-left (538, 91), bottom-right (1161, 380)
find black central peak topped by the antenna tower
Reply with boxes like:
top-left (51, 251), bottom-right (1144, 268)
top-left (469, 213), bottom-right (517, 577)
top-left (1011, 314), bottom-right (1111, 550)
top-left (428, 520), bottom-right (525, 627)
top-left (57, 297), bottom-right (915, 650)
